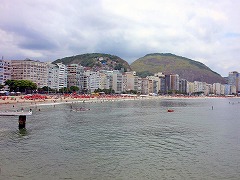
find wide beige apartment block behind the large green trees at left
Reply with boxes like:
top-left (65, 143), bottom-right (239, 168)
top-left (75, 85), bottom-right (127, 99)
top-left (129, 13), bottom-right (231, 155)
top-left (11, 59), bottom-right (48, 88)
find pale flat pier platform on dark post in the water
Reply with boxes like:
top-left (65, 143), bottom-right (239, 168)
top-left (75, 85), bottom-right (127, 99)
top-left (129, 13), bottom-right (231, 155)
top-left (0, 111), bottom-right (32, 129)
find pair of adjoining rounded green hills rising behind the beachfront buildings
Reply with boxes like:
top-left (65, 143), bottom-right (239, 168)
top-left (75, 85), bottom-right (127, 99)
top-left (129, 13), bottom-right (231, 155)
top-left (52, 53), bottom-right (226, 84)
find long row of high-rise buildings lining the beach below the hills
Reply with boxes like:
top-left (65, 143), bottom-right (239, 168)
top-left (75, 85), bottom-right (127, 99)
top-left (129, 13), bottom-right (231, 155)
top-left (0, 60), bottom-right (240, 95)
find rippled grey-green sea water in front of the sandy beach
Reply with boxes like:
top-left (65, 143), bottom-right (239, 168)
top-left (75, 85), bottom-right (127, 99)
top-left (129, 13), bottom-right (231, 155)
top-left (0, 98), bottom-right (240, 180)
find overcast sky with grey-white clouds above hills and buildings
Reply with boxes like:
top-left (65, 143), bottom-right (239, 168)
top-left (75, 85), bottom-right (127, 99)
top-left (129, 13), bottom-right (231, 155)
top-left (0, 0), bottom-right (240, 76)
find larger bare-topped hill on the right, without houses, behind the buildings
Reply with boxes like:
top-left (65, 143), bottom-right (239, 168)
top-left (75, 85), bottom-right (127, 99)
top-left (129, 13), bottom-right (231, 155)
top-left (130, 53), bottom-right (226, 84)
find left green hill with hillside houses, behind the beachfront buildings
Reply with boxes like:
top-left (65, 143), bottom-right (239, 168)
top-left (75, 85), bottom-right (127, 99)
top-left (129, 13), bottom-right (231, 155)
top-left (52, 53), bottom-right (131, 71)
